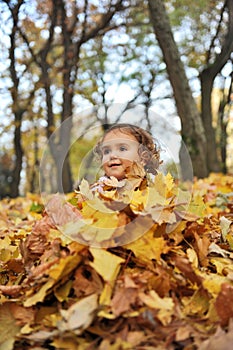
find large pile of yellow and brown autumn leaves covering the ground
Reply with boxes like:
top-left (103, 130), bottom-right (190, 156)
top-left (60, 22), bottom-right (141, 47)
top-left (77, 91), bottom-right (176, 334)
top-left (0, 174), bottom-right (233, 350)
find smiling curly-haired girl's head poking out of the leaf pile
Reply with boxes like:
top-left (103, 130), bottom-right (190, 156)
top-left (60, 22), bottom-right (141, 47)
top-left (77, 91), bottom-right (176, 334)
top-left (92, 124), bottom-right (161, 189)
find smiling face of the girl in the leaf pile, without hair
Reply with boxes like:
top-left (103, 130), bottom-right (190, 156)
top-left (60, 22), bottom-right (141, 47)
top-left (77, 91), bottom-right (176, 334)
top-left (101, 129), bottom-right (140, 180)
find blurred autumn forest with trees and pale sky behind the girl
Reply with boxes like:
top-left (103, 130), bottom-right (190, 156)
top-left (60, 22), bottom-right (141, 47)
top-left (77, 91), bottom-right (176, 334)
top-left (0, 0), bottom-right (233, 198)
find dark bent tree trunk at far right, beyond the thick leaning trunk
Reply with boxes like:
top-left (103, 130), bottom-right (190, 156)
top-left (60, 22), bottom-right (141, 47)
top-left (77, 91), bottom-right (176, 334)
top-left (200, 0), bottom-right (233, 172)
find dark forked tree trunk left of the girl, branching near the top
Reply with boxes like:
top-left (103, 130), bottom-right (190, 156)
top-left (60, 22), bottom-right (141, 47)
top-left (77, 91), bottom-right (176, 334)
top-left (37, 0), bottom-right (124, 193)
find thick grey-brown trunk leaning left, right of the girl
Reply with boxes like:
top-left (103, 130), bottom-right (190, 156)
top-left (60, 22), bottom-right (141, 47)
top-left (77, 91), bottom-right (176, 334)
top-left (148, 0), bottom-right (208, 179)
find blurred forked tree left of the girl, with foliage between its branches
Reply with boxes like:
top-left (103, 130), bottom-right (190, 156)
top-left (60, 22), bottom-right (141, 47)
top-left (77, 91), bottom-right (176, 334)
top-left (23, 0), bottom-right (129, 192)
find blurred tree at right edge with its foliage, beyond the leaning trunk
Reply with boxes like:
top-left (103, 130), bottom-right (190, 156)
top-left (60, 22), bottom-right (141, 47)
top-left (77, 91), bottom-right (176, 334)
top-left (166, 0), bottom-right (233, 172)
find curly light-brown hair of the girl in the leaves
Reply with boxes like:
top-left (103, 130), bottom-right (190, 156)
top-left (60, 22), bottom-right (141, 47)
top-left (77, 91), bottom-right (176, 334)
top-left (94, 123), bottom-right (162, 175)
